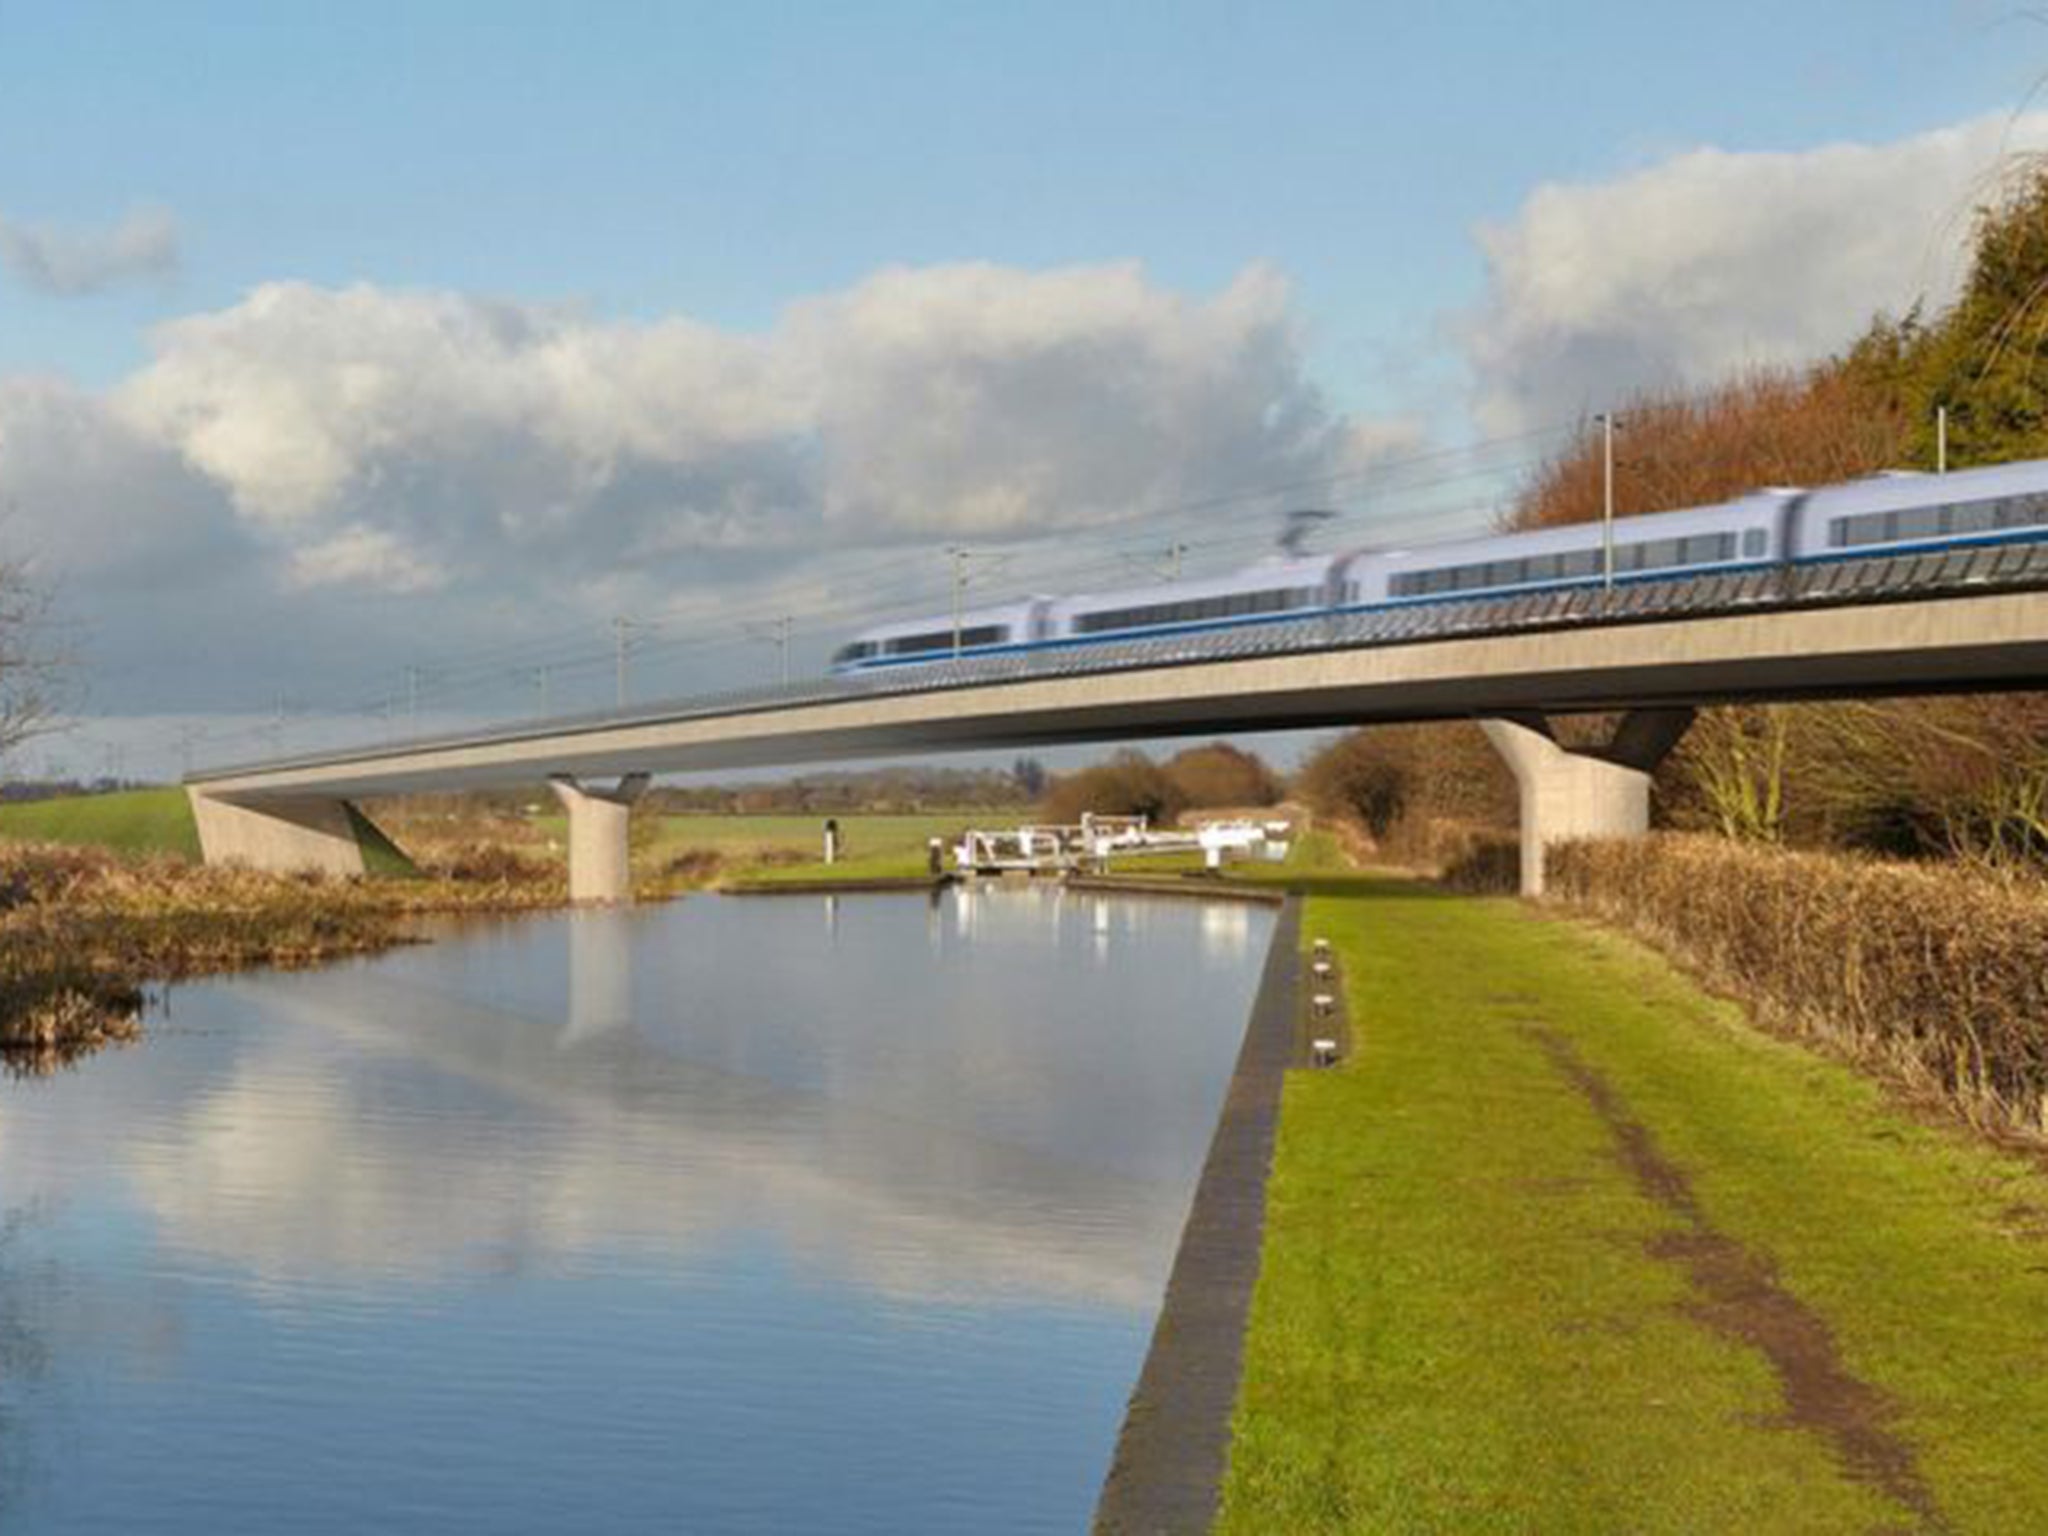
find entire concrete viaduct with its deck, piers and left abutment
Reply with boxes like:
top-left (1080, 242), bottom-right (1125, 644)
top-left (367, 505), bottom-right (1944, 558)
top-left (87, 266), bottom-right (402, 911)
top-left (186, 569), bottom-right (2048, 901)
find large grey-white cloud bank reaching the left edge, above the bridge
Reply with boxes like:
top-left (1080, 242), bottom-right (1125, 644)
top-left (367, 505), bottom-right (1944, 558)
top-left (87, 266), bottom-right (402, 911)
top-left (0, 264), bottom-right (1415, 713)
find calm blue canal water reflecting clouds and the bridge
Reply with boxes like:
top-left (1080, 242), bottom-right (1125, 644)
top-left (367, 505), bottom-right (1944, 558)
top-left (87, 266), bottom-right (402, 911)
top-left (0, 889), bottom-right (1272, 1536)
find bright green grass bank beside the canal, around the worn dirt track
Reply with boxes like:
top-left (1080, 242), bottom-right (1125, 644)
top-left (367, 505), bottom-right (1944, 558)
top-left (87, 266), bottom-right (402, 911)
top-left (1219, 881), bottom-right (2048, 1532)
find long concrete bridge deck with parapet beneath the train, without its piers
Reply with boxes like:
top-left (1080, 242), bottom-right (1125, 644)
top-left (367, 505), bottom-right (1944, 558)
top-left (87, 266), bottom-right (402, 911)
top-left (188, 541), bottom-right (2048, 797)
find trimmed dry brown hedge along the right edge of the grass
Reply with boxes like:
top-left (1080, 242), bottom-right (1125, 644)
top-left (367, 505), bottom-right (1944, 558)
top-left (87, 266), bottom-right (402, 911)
top-left (1544, 834), bottom-right (2048, 1135)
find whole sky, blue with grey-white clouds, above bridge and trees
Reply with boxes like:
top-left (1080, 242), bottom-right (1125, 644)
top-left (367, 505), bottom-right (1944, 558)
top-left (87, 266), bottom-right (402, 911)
top-left (0, 0), bottom-right (2048, 770)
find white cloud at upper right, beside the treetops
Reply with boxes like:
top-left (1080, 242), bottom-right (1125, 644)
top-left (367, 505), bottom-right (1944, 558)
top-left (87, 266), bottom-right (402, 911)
top-left (1458, 115), bottom-right (2048, 432)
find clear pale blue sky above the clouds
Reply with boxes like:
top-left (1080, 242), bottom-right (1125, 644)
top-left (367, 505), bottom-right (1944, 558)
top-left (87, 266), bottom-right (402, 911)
top-left (0, 0), bottom-right (2048, 410)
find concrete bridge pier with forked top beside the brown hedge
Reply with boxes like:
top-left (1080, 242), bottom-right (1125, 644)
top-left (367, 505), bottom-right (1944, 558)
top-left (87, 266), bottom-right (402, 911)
top-left (1479, 709), bottom-right (1694, 897)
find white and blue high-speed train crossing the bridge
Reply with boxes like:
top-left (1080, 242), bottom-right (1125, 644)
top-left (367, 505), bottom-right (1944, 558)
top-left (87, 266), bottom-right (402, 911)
top-left (831, 459), bottom-right (2048, 674)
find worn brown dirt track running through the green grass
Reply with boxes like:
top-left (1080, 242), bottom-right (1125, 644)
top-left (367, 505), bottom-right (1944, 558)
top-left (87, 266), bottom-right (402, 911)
top-left (1524, 1024), bottom-right (1946, 1530)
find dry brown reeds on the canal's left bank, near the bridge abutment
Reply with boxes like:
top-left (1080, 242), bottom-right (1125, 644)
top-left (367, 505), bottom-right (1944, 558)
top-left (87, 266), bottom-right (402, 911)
top-left (0, 844), bottom-right (567, 1071)
